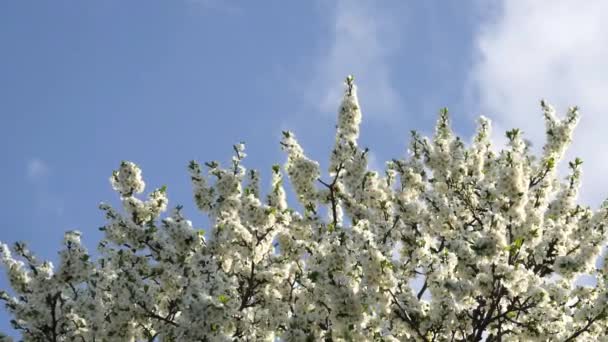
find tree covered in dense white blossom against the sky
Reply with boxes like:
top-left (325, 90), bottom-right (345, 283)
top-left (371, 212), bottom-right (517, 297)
top-left (0, 77), bottom-right (608, 341)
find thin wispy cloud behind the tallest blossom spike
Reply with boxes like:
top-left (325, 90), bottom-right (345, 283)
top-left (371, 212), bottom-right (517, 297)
top-left (308, 0), bottom-right (400, 118)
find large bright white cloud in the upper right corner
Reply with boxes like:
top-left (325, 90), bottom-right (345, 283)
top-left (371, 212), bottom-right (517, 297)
top-left (471, 0), bottom-right (608, 204)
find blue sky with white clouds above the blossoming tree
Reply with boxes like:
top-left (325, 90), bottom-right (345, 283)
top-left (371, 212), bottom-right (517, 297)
top-left (0, 0), bottom-right (608, 331)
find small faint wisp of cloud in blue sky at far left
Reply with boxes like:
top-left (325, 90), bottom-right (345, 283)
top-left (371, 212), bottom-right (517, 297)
top-left (25, 158), bottom-right (64, 216)
